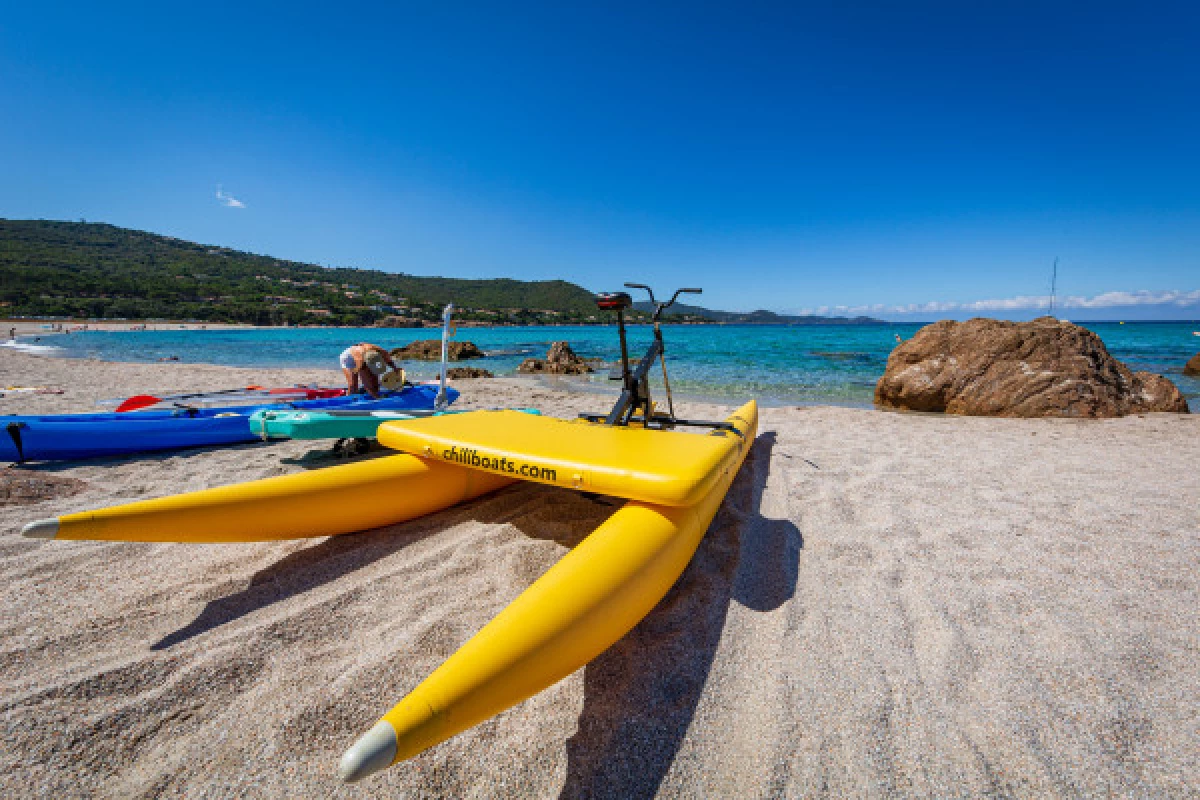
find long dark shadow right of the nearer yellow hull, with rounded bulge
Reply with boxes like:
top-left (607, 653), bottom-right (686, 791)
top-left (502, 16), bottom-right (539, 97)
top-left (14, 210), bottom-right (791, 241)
top-left (559, 433), bottom-right (804, 800)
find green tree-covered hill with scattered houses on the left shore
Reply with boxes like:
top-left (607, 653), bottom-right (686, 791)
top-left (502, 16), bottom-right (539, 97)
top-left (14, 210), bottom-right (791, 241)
top-left (0, 219), bottom-right (607, 325)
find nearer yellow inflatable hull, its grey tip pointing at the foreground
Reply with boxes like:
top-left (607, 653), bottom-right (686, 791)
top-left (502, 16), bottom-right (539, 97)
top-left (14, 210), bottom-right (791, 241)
top-left (340, 402), bottom-right (758, 781)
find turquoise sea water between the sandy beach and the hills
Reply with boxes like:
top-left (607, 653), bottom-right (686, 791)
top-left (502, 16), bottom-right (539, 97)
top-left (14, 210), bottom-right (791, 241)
top-left (16, 321), bottom-right (1200, 411)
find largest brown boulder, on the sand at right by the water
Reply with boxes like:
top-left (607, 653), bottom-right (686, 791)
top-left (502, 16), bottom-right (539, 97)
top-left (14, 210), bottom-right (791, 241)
top-left (875, 317), bottom-right (1188, 417)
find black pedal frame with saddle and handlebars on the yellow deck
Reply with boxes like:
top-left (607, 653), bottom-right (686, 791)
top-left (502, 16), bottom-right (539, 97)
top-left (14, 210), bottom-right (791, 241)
top-left (580, 283), bottom-right (742, 435)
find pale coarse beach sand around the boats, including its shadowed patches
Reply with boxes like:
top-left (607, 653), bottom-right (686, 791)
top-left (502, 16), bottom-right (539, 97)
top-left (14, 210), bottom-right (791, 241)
top-left (0, 350), bottom-right (1200, 798)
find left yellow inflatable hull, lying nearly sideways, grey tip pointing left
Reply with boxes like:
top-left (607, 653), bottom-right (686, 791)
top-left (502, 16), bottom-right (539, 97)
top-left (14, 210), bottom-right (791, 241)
top-left (23, 455), bottom-right (512, 542)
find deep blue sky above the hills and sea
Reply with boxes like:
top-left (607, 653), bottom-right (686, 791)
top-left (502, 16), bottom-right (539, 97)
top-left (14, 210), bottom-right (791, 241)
top-left (0, 2), bottom-right (1200, 319)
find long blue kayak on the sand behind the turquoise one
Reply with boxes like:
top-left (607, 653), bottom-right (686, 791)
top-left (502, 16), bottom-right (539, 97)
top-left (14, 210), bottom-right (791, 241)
top-left (0, 385), bottom-right (458, 462)
